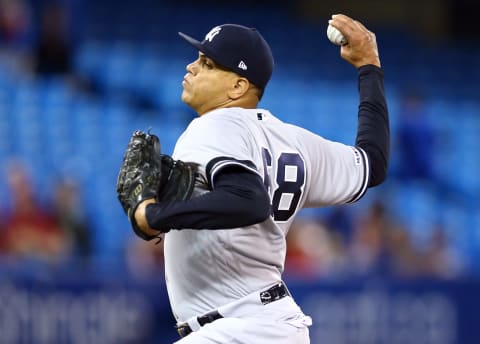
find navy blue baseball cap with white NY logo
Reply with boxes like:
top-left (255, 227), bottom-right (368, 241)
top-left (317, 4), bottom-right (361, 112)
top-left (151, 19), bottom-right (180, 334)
top-left (178, 24), bottom-right (274, 89)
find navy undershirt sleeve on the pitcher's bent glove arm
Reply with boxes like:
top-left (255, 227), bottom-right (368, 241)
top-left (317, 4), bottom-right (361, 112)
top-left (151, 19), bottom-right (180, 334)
top-left (146, 166), bottom-right (270, 232)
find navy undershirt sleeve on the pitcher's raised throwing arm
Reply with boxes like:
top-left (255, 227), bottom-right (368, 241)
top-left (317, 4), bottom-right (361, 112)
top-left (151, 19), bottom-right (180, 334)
top-left (356, 65), bottom-right (390, 187)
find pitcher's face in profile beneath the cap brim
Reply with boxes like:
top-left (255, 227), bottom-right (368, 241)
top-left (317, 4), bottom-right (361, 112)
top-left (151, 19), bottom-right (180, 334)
top-left (182, 53), bottom-right (237, 116)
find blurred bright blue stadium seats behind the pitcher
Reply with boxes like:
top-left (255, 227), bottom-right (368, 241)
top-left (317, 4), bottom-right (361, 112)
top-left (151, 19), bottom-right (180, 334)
top-left (0, 1), bottom-right (480, 272)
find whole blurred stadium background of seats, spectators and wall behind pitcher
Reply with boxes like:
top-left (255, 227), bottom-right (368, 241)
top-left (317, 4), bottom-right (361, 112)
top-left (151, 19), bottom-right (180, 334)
top-left (0, 0), bottom-right (480, 344)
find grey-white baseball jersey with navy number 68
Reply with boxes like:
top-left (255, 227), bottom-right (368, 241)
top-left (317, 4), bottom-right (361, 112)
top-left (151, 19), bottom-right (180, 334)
top-left (165, 108), bottom-right (369, 322)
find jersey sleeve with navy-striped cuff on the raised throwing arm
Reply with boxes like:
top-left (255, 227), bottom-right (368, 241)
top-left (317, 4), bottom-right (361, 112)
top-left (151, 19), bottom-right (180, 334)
top-left (304, 127), bottom-right (369, 208)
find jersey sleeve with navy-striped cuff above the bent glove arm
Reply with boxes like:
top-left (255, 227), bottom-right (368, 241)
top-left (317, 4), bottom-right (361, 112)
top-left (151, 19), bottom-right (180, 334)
top-left (173, 114), bottom-right (259, 186)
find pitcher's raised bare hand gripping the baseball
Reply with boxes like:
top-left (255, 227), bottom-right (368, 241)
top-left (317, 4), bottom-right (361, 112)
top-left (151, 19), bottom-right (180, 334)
top-left (328, 14), bottom-right (380, 68)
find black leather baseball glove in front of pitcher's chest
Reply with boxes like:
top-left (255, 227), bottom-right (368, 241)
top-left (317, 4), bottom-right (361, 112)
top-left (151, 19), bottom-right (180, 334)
top-left (117, 130), bottom-right (196, 240)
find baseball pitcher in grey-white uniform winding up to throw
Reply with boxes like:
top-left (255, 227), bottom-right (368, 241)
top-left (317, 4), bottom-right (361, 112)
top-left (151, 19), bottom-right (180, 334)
top-left (117, 14), bottom-right (389, 344)
